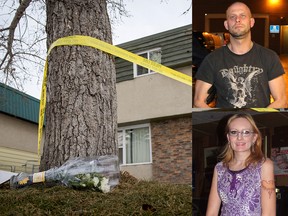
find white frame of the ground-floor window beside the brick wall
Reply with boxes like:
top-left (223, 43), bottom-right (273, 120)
top-left (117, 123), bottom-right (152, 166)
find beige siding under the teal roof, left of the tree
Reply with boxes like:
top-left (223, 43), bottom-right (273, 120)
top-left (0, 113), bottom-right (38, 173)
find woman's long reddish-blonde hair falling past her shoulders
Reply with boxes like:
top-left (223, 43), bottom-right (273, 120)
top-left (219, 113), bottom-right (264, 167)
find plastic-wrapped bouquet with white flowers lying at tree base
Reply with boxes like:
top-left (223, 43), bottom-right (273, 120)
top-left (10, 155), bottom-right (120, 193)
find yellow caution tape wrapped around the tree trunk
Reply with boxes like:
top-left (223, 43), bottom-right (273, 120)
top-left (38, 35), bottom-right (192, 160)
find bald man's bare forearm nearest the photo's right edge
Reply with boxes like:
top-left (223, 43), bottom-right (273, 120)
top-left (268, 76), bottom-right (288, 108)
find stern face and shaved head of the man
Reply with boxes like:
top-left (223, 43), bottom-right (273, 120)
top-left (224, 3), bottom-right (255, 39)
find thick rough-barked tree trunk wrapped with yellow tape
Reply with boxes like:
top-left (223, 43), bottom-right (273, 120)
top-left (40, 0), bottom-right (118, 170)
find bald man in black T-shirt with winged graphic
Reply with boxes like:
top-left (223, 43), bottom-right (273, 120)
top-left (193, 2), bottom-right (287, 108)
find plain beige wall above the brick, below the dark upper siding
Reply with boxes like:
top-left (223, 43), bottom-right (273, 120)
top-left (117, 66), bottom-right (192, 124)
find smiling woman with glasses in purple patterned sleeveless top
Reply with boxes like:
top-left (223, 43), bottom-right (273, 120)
top-left (206, 113), bottom-right (276, 216)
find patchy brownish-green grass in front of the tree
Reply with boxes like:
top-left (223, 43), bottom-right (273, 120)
top-left (0, 173), bottom-right (192, 216)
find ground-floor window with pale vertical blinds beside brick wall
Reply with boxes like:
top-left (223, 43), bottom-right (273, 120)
top-left (118, 124), bottom-right (152, 164)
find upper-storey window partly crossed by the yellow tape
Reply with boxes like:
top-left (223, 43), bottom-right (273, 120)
top-left (133, 48), bottom-right (161, 77)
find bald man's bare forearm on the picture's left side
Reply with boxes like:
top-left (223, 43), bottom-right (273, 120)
top-left (193, 80), bottom-right (212, 108)
